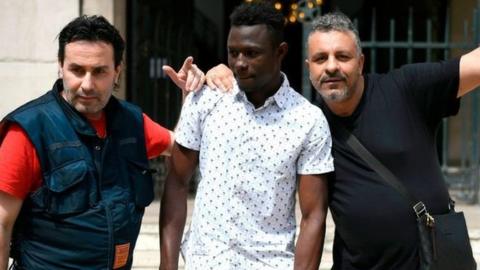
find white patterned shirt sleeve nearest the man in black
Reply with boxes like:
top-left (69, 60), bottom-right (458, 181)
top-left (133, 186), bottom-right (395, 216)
top-left (297, 107), bottom-right (334, 174)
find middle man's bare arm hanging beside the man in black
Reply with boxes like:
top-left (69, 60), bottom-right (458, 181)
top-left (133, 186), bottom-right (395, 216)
top-left (294, 174), bottom-right (328, 270)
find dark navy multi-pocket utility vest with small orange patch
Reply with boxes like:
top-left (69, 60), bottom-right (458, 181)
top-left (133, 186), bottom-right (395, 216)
top-left (0, 80), bottom-right (153, 269)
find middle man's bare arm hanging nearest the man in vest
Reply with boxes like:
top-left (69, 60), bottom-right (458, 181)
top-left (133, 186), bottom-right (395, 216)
top-left (160, 143), bottom-right (198, 270)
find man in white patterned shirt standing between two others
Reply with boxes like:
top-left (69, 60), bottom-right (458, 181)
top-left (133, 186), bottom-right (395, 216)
top-left (160, 3), bottom-right (333, 270)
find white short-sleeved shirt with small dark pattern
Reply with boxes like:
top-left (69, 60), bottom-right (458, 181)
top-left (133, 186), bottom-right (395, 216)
top-left (176, 76), bottom-right (333, 270)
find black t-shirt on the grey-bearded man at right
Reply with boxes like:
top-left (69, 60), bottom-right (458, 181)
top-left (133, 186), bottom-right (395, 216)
top-left (320, 59), bottom-right (459, 270)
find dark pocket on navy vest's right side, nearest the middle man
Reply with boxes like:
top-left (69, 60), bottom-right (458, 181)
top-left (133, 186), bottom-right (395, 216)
top-left (127, 160), bottom-right (155, 207)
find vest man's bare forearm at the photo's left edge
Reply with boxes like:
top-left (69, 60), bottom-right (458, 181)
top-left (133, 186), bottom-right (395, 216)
top-left (0, 191), bottom-right (23, 270)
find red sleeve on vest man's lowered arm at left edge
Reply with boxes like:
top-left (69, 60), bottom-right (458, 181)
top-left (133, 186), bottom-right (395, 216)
top-left (0, 124), bottom-right (42, 200)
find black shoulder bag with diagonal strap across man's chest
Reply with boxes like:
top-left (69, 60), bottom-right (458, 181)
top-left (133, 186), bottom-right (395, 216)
top-left (337, 125), bottom-right (477, 270)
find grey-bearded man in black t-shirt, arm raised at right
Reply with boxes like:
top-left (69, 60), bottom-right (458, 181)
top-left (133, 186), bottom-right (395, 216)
top-left (203, 10), bottom-right (480, 270)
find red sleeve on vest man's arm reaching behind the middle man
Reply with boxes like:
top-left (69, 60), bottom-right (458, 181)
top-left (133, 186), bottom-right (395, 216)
top-left (143, 114), bottom-right (171, 159)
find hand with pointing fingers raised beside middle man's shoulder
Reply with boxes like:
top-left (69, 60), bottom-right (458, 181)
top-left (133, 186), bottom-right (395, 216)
top-left (162, 56), bottom-right (205, 97)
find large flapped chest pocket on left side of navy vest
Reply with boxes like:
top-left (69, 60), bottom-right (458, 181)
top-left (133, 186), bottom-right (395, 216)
top-left (32, 160), bottom-right (96, 215)
